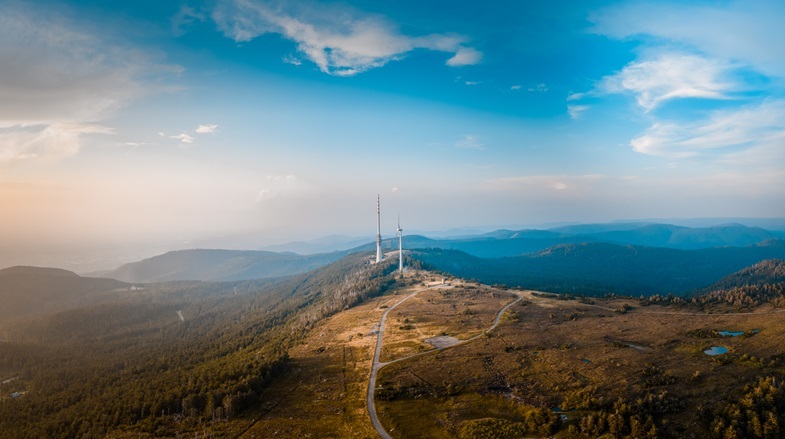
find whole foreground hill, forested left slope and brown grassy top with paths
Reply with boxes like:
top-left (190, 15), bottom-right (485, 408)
top-left (0, 252), bottom-right (785, 439)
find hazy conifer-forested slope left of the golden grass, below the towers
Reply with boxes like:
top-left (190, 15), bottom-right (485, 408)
top-left (0, 255), bottom-right (396, 438)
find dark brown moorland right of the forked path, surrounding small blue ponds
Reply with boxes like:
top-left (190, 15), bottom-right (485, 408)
top-left (377, 296), bottom-right (785, 438)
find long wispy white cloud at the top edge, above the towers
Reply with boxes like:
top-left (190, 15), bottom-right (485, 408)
top-left (212, 0), bottom-right (482, 76)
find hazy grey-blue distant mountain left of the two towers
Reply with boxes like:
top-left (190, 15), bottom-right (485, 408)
top-left (95, 249), bottom-right (346, 283)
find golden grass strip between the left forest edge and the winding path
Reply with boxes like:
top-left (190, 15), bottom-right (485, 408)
top-left (232, 272), bottom-right (456, 438)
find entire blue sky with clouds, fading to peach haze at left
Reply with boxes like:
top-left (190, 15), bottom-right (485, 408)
top-left (0, 0), bottom-right (785, 263)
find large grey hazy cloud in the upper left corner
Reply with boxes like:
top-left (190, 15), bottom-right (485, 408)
top-left (0, 4), bottom-right (180, 160)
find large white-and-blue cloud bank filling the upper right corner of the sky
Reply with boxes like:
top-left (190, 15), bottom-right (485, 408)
top-left (581, 0), bottom-right (785, 169)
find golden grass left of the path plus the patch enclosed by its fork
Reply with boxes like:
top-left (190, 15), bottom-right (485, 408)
top-left (233, 272), bottom-right (515, 438)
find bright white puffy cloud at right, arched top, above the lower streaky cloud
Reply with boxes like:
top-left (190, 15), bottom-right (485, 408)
top-left (598, 53), bottom-right (740, 111)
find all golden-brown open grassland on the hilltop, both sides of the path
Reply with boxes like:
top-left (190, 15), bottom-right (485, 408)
top-left (234, 272), bottom-right (785, 438)
